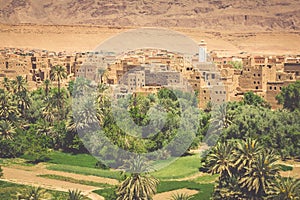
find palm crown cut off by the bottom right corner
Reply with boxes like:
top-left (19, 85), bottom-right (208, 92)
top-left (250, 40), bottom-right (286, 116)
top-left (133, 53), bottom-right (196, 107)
top-left (268, 177), bottom-right (300, 200)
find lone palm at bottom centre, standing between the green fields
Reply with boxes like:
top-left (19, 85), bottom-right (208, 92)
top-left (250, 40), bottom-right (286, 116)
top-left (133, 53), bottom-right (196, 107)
top-left (117, 156), bottom-right (159, 200)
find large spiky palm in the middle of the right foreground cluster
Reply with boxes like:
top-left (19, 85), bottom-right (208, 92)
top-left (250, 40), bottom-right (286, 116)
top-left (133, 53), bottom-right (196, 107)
top-left (239, 151), bottom-right (279, 197)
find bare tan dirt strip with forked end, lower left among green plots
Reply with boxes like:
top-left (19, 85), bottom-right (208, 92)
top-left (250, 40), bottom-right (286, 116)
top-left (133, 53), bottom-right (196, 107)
top-left (2, 167), bottom-right (118, 200)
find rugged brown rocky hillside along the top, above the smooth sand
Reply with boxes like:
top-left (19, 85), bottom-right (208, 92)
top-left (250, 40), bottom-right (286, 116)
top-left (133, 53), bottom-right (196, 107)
top-left (0, 0), bottom-right (300, 31)
